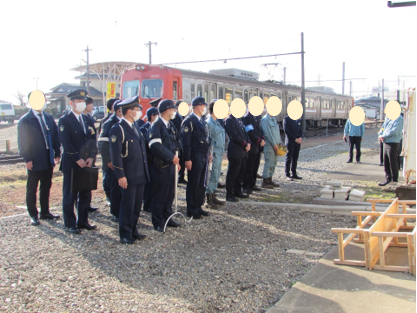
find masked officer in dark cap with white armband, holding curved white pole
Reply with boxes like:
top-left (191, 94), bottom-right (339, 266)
top-left (147, 99), bottom-right (180, 232)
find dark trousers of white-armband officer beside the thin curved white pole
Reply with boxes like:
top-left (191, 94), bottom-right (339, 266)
top-left (151, 164), bottom-right (175, 227)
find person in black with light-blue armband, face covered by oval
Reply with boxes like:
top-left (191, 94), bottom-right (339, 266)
top-left (243, 111), bottom-right (265, 194)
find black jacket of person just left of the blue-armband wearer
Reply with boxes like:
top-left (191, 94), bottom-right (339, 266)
top-left (226, 114), bottom-right (250, 158)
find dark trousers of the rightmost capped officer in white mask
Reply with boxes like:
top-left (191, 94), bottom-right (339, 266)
top-left (186, 153), bottom-right (207, 215)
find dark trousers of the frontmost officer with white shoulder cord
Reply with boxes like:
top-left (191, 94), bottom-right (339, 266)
top-left (119, 181), bottom-right (145, 239)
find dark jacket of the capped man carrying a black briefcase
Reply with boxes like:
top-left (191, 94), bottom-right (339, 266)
top-left (58, 111), bottom-right (97, 173)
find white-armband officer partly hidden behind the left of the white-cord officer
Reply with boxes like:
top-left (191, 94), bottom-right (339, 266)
top-left (97, 100), bottom-right (123, 222)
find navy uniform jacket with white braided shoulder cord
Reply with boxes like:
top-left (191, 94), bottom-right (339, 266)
top-left (110, 119), bottom-right (150, 185)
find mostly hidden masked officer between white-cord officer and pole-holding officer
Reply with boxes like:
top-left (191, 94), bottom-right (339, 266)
top-left (140, 107), bottom-right (159, 212)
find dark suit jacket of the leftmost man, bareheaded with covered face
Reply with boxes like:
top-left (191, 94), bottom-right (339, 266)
top-left (17, 110), bottom-right (61, 171)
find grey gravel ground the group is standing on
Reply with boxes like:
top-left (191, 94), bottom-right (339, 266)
top-left (0, 126), bottom-right (384, 312)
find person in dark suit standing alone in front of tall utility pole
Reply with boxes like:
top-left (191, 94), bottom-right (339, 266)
top-left (283, 115), bottom-right (303, 180)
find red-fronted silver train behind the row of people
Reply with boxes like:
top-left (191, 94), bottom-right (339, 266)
top-left (122, 64), bottom-right (353, 127)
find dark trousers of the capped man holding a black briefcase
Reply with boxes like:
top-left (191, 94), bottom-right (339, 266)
top-left (62, 172), bottom-right (91, 227)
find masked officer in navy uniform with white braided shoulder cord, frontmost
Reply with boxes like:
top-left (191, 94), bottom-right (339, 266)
top-left (110, 96), bottom-right (149, 244)
